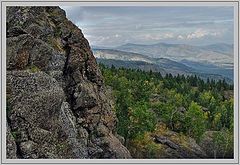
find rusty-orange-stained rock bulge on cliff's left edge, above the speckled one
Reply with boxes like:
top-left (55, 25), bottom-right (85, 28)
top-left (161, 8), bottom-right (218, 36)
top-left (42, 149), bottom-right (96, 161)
top-left (7, 34), bottom-right (62, 71)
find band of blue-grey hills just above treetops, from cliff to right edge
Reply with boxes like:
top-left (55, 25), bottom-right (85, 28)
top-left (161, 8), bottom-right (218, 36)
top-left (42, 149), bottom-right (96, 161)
top-left (93, 49), bottom-right (233, 82)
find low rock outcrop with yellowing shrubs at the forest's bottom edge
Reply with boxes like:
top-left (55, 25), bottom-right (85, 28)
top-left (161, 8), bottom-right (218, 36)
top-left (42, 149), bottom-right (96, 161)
top-left (129, 124), bottom-right (207, 159)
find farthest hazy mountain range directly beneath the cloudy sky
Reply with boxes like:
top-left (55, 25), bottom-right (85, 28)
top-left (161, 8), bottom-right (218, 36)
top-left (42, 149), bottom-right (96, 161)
top-left (113, 43), bottom-right (233, 69)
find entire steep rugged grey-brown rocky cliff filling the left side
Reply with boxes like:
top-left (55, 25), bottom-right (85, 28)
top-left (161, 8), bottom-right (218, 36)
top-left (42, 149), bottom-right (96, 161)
top-left (7, 7), bottom-right (131, 159)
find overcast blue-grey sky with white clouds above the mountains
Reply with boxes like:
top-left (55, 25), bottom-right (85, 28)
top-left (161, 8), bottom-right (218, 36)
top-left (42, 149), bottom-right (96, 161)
top-left (61, 6), bottom-right (234, 47)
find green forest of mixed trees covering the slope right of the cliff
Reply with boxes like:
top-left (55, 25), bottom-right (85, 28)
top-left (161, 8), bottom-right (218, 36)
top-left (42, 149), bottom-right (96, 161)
top-left (99, 64), bottom-right (234, 158)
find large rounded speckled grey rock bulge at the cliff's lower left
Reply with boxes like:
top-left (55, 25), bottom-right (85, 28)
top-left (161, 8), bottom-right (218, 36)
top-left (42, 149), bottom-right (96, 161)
top-left (7, 71), bottom-right (68, 158)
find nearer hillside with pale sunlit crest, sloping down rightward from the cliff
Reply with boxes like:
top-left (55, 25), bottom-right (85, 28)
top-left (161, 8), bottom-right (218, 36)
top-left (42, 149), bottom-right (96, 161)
top-left (93, 49), bottom-right (194, 75)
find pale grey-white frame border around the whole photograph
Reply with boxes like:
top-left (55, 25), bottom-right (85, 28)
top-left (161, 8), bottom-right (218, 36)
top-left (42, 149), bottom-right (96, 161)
top-left (1, 0), bottom-right (240, 164)
